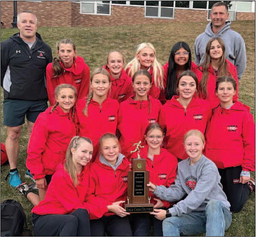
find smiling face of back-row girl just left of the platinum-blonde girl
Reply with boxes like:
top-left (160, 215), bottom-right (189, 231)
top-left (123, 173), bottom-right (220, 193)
top-left (107, 52), bottom-right (124, 75)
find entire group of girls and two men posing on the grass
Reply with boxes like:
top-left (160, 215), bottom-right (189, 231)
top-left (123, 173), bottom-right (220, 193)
top-left (1, 2), bottom-right (255, 236)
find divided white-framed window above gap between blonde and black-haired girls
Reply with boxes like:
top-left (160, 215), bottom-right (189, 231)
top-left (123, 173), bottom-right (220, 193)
top-left (145, 1), bottom-right (174, 18)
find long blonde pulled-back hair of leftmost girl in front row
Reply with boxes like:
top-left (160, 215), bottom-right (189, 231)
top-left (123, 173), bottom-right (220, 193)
top-left (64, 136), bottom-right (93, 186)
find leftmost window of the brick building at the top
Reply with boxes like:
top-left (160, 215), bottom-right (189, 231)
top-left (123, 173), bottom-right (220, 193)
top-left (80, 1), bottom-right (111, 15)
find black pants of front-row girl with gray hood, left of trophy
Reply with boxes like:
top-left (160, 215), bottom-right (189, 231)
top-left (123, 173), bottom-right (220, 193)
top-left (90, 215), bottom-right (132, 236)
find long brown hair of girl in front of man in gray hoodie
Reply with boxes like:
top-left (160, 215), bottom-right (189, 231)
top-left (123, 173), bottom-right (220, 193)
top-left (199, 37), bottom-right (231, 98)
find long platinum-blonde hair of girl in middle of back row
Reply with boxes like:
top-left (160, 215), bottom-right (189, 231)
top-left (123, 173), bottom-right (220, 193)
top-left (125, 42), bottom-right (164, 89)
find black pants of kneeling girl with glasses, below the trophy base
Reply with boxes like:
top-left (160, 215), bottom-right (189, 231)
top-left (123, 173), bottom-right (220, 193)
top-left (129, 213), bottom-right (163, 236)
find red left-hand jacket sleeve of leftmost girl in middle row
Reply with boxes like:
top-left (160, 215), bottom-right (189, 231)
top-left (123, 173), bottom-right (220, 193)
top-left (26, 113), bottom-right (48, 179)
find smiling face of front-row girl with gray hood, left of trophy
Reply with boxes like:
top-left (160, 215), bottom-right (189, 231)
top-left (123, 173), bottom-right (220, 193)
top-left (100, 138), bottom-right (120, 165)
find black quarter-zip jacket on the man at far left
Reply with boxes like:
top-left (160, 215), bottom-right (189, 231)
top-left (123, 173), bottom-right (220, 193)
top-left (1, 33), bottom-right (52, 100)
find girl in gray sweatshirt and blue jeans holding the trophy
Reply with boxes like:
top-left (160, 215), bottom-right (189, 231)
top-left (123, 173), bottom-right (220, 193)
top-left (148, 130), bottom-right (232, 236)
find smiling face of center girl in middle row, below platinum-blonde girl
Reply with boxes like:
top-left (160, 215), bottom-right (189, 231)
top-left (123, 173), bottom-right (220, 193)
top-left (133, 74), bottom-right (151, 100)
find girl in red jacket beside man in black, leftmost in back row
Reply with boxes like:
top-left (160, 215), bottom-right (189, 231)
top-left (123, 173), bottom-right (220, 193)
top-left (46, 39), bottom-right (90, 105)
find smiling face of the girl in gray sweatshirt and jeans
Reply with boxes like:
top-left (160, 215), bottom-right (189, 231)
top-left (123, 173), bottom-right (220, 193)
top-left (184, 135), bottom-right (204, 162)
